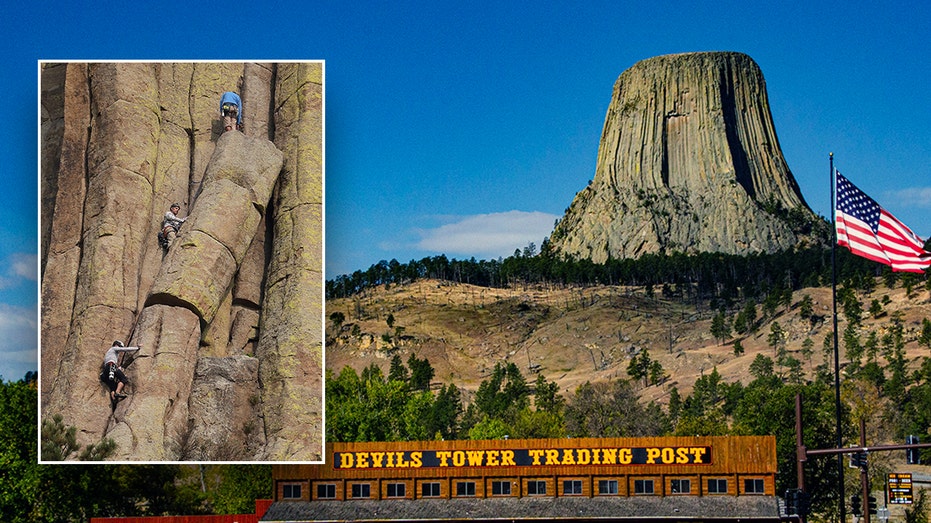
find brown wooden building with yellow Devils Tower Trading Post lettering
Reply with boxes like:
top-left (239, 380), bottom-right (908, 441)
top-left (262, 436), bottom-right (780, 522)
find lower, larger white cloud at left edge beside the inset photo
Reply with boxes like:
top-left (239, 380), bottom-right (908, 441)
top-left (0, 304), bottom-right (39, 381)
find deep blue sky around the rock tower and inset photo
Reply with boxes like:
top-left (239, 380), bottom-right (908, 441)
top-left (0, 0), bottom-right (931, 380)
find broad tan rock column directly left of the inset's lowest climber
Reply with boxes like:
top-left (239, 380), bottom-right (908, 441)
top-left (43, 64), bottom-right (159, 444)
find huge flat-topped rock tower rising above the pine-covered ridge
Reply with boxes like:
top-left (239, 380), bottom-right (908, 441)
top-left (550, 52), bottom-right (817, 262)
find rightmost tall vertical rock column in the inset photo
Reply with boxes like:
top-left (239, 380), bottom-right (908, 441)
top-left (257, 64), bottom-right (323, 460)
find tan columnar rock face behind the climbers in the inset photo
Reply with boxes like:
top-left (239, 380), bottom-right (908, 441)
top-left (40, 63), bottom-right (323, 461)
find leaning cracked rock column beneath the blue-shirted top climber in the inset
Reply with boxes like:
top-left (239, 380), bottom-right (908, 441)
top-left (108, 132), bottom-right (283, 460)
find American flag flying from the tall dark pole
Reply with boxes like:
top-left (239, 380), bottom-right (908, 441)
top-left (835, 173), bottom-right (931, 272)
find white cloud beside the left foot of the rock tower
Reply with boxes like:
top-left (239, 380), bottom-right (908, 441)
top-left (417, 211), bottom-right (558, 258)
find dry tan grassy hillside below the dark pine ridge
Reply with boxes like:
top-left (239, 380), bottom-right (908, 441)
top-left (326, 279), bottom-right (931, 403)
